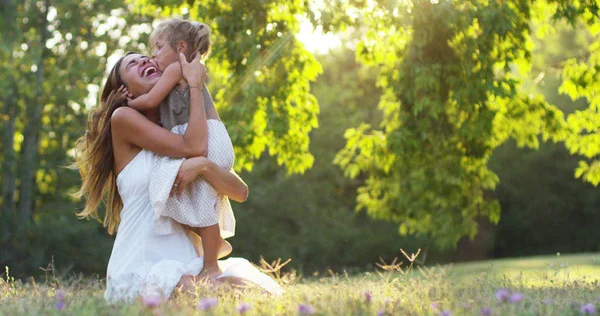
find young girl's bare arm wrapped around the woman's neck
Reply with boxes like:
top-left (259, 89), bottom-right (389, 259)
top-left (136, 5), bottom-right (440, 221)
top-left (127, 62), bottom-right (183, 111)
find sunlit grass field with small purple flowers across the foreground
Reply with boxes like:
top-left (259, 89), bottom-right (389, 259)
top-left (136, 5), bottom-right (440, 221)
top-left (0, 254), bottom-right (600, 315)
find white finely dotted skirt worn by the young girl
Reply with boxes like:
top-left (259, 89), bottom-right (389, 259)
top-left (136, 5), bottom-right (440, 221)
top-left (149, 119), bottom-right (235, 238)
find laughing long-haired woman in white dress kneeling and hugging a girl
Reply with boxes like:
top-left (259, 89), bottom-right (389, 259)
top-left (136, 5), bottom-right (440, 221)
top-left (76, 53), bottom-right (282, 301)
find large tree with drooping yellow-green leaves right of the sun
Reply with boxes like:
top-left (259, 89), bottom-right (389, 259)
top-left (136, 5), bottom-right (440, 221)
top-left (336, 0), bottom-right (576, 247)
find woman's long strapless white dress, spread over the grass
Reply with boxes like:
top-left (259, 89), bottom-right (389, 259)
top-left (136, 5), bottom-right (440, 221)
top-left (104, 150), bottom-right (283, 302)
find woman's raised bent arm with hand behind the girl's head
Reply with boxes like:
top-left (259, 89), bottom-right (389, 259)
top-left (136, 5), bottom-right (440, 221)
top-left (111, 54), bottom-right (208, 158)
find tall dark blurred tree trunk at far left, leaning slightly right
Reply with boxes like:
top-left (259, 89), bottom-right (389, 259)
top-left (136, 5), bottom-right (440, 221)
top-left (19, 0), bottom-right (50, 220)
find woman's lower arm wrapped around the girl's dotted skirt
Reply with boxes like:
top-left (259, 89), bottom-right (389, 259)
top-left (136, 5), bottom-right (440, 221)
top-left (171, 157), bottom-right (248, 202)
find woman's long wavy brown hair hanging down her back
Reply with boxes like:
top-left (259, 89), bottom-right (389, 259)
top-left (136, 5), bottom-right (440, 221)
top-left (73, 52), bottom-right (133, 234)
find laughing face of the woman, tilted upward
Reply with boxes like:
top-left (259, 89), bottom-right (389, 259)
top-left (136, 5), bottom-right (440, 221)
top-left (118, 54), bottom-right (161, 97)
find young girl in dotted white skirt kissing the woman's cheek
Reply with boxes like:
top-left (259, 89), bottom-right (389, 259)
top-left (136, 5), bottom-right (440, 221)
top-left (128, 19), bottom-right (235, 279)
